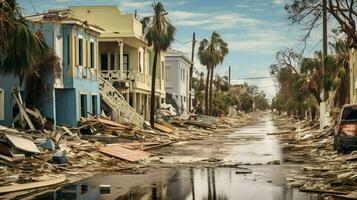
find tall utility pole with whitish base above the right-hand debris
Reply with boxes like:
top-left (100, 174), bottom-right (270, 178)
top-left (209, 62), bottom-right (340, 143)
top-left (320, 0), bottom-right (328, 130)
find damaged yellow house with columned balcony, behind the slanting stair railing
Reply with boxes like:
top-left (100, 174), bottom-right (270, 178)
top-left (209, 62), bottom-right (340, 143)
top-left (69, 6), bottom-right (165, 120)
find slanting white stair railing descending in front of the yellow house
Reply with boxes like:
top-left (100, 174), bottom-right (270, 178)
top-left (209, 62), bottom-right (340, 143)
top-left (98, 76), bottom-right (144, 127)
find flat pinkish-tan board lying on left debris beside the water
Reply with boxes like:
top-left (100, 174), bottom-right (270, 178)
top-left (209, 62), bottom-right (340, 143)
top-left (99, 145), bottom-right (151, 162)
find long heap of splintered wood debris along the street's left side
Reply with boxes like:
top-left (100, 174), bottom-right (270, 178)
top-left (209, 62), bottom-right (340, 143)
top-left (0, 101), bottom-right (253, 198)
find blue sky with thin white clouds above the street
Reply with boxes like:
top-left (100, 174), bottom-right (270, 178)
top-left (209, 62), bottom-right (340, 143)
top-left (18, 0), bottom-right (321, 99)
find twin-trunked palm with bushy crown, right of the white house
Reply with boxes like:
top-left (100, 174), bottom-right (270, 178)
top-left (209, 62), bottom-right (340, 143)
top-left (198, 32), bottom-right (228, 114)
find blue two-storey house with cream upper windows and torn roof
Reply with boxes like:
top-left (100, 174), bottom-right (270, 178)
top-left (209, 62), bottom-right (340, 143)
top-left (0, 10), bottom-right (102, 126)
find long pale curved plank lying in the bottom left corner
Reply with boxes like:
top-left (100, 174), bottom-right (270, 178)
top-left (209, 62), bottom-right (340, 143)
top-left (0, 175), bottom-right (66, 194)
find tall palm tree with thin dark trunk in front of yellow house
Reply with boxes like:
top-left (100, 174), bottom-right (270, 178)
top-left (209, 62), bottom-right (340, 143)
top-left (141, 2), bottom-right (176, 127)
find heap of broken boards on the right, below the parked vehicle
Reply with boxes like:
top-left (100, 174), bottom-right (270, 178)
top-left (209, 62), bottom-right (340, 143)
top-left (275, 115), bottom-right (357, 199)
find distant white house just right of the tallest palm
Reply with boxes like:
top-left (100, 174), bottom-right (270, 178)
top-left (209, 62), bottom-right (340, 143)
top-left (165, 49), bottom-right (192, 113)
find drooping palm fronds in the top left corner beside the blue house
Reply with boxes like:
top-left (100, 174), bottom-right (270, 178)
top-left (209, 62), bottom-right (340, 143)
top-left (0, 0), bottom-right (48, 84)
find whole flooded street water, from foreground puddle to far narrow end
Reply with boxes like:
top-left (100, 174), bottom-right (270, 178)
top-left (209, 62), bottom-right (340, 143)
top-left (37, 114), bottom-right (318, 200)
